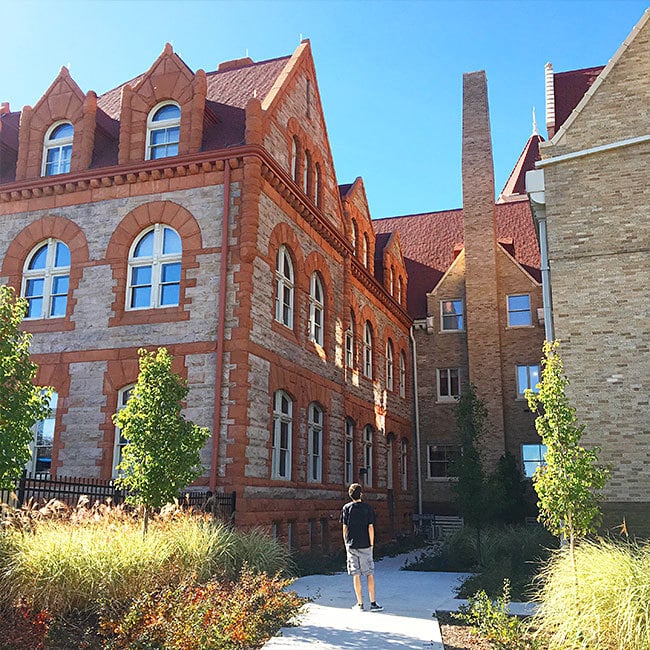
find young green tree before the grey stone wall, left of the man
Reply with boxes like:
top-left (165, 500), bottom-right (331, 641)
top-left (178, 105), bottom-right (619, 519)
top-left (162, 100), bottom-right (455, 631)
top-left (113, 348), bottom-right (210, 534)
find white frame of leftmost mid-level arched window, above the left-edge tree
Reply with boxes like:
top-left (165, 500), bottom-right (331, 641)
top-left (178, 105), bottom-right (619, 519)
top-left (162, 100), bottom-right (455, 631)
top-left (20, 237), bottom-right (72, 321)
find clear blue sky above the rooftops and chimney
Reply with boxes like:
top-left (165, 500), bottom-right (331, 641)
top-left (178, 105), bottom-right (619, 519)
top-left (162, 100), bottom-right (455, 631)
top-left (0, 0), bottom-right (648, 218)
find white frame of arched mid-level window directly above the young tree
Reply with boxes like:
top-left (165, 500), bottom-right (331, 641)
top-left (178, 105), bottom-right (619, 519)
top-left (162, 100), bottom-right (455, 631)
top-left (124, 222), bottom-right (183, 311)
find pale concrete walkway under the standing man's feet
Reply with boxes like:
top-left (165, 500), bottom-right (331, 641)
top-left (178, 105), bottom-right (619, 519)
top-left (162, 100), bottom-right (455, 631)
top-left (264, 552), bottom-right (465, 650)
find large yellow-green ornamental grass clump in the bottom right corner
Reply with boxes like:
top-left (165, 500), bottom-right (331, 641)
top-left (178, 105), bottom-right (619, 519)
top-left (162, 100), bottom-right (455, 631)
top-left (535, 540), bottom-right (650, 650)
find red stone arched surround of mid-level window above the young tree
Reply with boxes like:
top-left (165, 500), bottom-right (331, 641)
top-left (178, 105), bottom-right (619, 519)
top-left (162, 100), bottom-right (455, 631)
top-left (106, 201), bottom-right (203, 327)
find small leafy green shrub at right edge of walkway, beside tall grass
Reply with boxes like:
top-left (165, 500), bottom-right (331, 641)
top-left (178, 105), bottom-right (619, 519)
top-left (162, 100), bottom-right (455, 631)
top-left (452, 579), bottom-right (533, 650)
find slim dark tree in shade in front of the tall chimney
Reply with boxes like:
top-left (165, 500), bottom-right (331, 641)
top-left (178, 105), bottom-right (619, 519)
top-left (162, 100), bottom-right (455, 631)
top-left (451, 384), bottom-right (489, 561)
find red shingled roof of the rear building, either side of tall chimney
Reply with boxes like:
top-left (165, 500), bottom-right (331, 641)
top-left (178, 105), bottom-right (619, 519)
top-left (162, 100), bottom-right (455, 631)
top-left (373, 200), bottom-right (541, 318)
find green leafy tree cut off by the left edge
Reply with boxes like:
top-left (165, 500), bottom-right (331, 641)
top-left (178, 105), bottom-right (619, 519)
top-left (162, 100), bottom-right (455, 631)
top-left (0, 285), bottom-right (51, 490)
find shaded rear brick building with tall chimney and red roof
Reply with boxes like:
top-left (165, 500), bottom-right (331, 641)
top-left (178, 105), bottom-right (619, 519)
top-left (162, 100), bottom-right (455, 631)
top-left (374, 72), bottom-right (544, 514)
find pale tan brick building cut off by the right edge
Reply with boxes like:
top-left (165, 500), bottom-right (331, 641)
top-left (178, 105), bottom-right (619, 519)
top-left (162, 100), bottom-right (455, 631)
top-left (528, 10), bottom-right (650, 534)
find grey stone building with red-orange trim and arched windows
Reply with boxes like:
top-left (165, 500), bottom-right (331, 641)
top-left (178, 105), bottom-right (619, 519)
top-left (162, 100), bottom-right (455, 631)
top-left (0, 41), bottom-right (413, 548)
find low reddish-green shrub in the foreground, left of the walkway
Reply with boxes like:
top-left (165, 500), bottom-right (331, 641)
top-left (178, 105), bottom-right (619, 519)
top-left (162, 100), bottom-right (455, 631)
top-left (102, 567), bottom-right (305, 650)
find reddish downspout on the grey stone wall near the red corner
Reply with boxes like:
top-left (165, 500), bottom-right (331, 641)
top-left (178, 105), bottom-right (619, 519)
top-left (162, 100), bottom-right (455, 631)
top-left (210, 160), bottom-right (230, 493)
